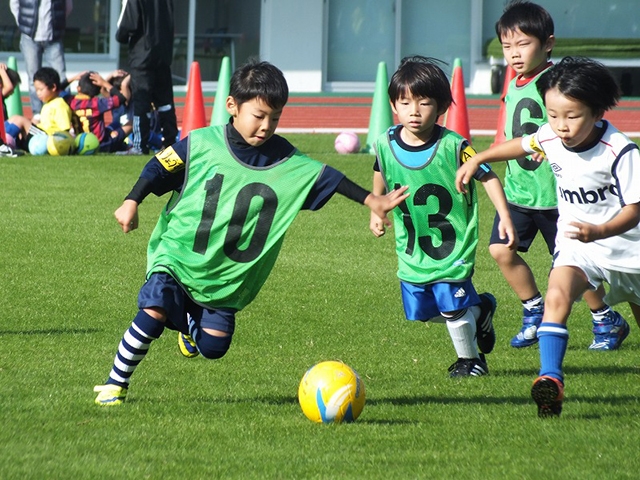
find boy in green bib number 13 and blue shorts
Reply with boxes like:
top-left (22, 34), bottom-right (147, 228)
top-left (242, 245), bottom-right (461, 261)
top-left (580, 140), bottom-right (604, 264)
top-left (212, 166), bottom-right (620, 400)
top-left (370, 56), bottom-right (518, 377)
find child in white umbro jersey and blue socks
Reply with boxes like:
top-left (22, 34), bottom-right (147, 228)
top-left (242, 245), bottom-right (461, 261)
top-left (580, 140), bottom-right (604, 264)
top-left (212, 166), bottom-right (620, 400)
top-left (456, 57), bottom-right (640, 416)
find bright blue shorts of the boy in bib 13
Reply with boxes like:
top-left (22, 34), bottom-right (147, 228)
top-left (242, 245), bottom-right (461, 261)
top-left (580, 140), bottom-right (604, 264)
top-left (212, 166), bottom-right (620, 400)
top-left (400, 279), bottom-right (480, 322)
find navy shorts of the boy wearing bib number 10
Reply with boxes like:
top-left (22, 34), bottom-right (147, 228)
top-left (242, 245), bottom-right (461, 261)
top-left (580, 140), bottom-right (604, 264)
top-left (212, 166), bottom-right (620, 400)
top-left (138, 273), bottom-right (236, 335)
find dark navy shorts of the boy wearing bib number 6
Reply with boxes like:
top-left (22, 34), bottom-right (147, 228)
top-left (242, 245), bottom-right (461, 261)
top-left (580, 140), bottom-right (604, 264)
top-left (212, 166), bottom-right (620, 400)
top-left (489, 204), bottom-right (558, 255)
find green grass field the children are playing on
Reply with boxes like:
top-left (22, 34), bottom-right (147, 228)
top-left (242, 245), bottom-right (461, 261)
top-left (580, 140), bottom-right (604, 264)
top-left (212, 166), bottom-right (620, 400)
top-left (0, 135), bottom-right (640, 479)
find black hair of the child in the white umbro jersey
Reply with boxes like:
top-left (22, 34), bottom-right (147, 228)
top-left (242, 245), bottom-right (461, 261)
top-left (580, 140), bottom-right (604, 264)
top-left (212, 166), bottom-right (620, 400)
top-left (537, 57), bottom-right (620, 115)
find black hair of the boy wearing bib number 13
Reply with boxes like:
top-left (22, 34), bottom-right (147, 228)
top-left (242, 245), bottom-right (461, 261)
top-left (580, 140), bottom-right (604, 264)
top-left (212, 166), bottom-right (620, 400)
top-left (387, 55), bottom-right (453, 111)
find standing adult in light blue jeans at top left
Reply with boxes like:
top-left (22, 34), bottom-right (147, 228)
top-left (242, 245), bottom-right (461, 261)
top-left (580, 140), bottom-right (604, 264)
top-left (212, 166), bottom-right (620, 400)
top-left (10, 0), bottom-right (73, 119)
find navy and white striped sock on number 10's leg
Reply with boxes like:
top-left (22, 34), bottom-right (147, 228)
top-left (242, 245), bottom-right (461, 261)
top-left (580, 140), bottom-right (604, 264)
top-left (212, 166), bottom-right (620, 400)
top-left (106, 310), bottom-right (164, 388)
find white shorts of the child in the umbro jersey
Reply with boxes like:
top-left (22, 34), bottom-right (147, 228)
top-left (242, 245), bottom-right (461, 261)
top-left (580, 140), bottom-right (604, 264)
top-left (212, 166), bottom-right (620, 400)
top-left (553, 249), bottom-right (640, 306)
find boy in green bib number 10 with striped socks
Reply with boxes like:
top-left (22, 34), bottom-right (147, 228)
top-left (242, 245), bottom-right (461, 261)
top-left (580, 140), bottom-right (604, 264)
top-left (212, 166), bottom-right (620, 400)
top-left (94, 61), bottom-right (408, 405)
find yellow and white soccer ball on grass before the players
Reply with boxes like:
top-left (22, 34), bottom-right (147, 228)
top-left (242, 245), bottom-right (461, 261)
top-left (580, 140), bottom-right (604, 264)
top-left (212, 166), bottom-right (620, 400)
top-left (298, 361), bottom-right (365, 423)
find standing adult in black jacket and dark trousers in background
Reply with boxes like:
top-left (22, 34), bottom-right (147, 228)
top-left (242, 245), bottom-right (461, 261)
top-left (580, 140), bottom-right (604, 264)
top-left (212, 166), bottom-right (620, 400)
top-left (116, 0), bottom-right (178, 154)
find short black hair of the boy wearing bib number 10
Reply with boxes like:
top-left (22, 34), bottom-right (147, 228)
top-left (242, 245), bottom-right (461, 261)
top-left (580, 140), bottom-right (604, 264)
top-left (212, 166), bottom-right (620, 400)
top-left (229, 59), bottom-right (289, 109)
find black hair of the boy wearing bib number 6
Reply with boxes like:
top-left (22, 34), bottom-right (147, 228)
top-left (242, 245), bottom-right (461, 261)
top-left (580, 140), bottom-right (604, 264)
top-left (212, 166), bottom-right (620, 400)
top-left (496, 0), bottom-right (554, 45)
